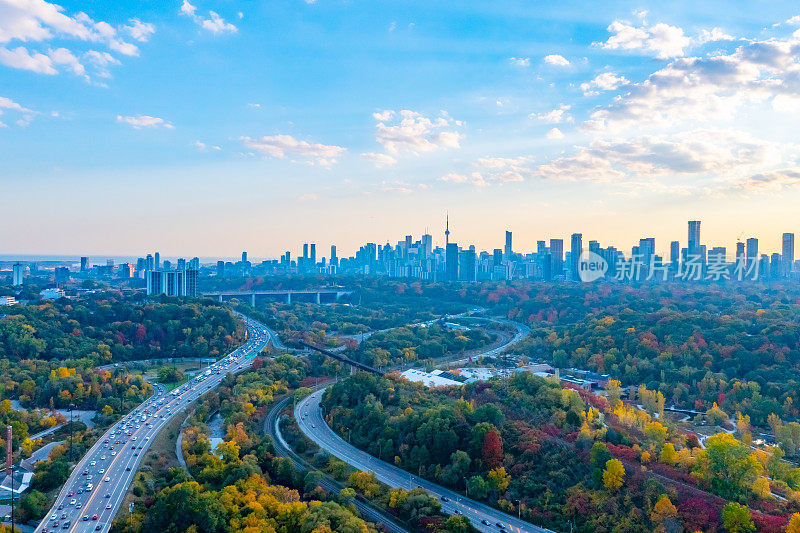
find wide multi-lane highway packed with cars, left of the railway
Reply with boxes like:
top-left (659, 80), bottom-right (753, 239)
top-left (36, 317), bottom-right (270, 533)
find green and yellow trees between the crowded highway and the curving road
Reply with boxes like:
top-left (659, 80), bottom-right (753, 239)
top-left (112, 355), bottom-right (469, 533)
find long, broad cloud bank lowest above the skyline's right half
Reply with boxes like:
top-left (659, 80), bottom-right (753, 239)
top-left (440, 129), bottom-right (800, 194)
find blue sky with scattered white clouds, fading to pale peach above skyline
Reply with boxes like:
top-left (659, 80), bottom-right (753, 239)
top-left (0, 0), bottom-right (800, 257)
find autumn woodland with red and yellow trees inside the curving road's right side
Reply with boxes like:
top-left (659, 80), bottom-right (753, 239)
top-left (323, 372), bottom-right (800, 533)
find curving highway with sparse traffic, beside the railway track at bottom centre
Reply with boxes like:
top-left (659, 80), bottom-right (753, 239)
top-left (294, 389), bottom-right (549, 533)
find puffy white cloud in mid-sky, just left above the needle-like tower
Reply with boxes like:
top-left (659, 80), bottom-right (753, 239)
top-left (373, 109), bottom-right (462, 154)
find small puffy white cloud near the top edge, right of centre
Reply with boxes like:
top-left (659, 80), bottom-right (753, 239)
top-left (594, 20), bottom-right (692, 59)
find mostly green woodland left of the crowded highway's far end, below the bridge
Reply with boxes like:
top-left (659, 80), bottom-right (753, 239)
top-left (0, 291), bottom-right (244, 365)
